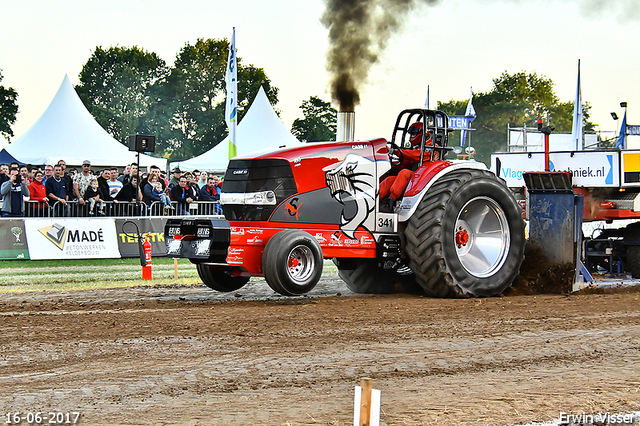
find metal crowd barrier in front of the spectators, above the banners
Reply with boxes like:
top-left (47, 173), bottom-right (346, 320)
top-left (24, 201), bottom-right (222, 217)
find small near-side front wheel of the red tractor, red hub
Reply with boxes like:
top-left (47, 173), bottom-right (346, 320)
top-left (262, 229), bottom-right (323, 296)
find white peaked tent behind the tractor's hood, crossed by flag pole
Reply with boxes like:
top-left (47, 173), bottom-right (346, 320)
top-left (171, 87), bottom-right (301, 171)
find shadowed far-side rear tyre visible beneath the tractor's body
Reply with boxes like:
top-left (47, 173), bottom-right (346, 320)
top-left (333, 259), bottom-right (422, 294)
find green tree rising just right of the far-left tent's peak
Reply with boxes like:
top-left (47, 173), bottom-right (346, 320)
top-left (76, 46), bottom-right (168, 144)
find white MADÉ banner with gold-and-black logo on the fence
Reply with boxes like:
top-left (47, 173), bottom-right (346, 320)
top-left (24, 218), bottom-right (120, 260)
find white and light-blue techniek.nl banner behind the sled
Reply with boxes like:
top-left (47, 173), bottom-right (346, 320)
top-left (491, 151), bottom-right (620, 188)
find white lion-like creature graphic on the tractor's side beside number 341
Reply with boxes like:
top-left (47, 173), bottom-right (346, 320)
top-left (325, 154), bottom-right (376, 240)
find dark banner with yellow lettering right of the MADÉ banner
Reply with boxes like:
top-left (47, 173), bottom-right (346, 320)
top-left (116, 217), bottom-right (167, 257)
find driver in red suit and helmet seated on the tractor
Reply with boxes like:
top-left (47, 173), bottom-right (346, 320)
top-left (380, 122), bottom-right (432, 207)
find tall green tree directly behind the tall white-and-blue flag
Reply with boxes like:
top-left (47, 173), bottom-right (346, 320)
top-left (163, 39), bottom-right (278, 160)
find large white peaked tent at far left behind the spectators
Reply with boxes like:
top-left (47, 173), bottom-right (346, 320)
top-left (5, 75), bottom-right (167, 169)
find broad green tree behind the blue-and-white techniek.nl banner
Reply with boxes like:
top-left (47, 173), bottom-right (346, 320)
top-left (438, 71), bottom-right (594, 164)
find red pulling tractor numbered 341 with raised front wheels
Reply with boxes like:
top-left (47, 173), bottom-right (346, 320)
top-left (165, 109), bottom-right (525, 297)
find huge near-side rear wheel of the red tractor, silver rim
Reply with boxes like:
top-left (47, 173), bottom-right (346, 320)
top-left (405, 170), bottom-right (525, 297)
